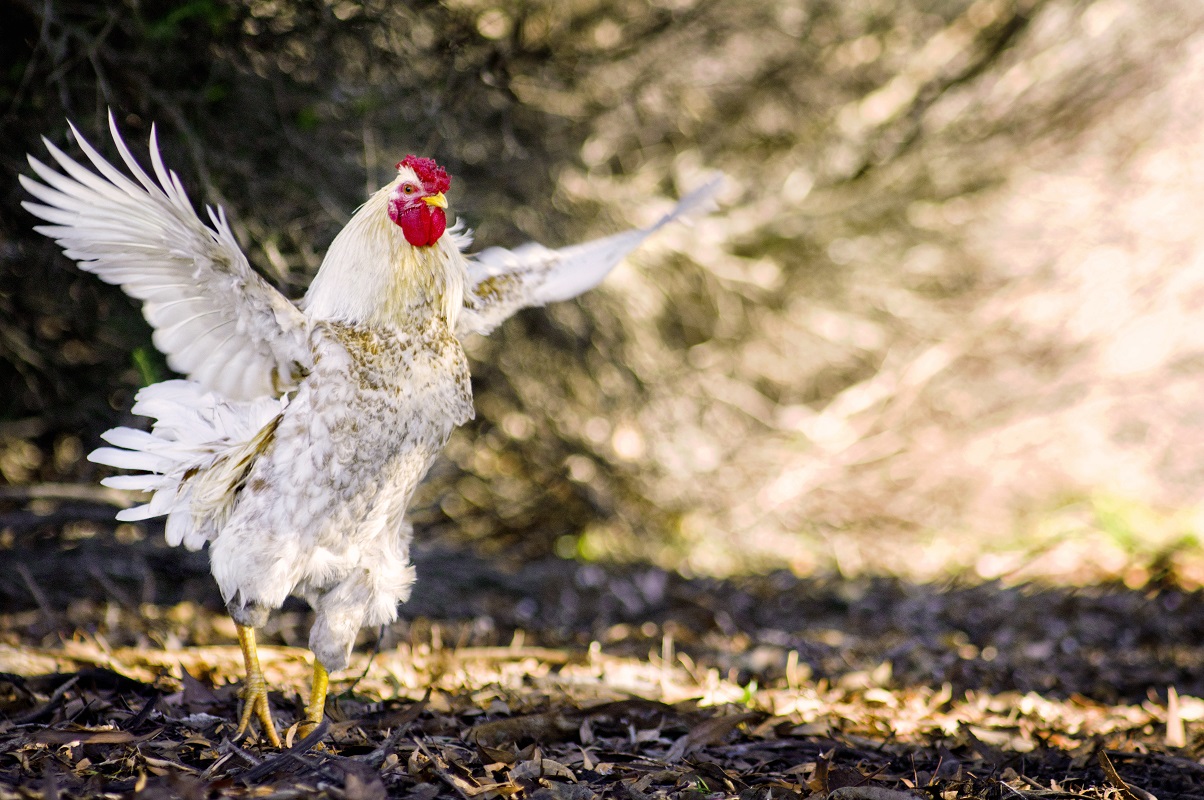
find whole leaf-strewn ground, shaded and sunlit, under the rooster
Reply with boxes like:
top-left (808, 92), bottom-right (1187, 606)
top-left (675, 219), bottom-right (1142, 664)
top-left (0, 518), bottom-right (1204, 800)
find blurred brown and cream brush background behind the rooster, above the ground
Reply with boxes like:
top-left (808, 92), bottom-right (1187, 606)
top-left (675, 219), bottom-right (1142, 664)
top-left (0, 0), bottom-right (1204, 586)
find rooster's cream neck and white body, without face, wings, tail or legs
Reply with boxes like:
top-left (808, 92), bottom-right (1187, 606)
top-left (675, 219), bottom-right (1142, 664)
top-left (204, 183), bottom-right (473, 670)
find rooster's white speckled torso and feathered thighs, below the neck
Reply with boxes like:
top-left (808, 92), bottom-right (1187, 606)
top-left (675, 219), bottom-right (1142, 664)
top-left (216, 317), bottom-right (473, 670)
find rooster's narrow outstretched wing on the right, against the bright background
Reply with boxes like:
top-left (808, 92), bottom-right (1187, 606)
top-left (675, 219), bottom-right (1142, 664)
top-left (456, 175), bottom-right (724, 336)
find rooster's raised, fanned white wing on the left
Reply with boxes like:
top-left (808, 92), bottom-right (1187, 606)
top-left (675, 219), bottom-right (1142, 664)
top-left (20, 113), bottom-right (311, 400)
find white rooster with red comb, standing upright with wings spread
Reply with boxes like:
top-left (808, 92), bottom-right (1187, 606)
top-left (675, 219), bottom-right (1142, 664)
top-left (20, 114), bottom-right (721, 747)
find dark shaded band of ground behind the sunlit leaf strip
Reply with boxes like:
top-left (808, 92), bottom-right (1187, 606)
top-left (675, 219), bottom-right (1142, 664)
top-left (0, 518), bottom-right (1204, 705)
